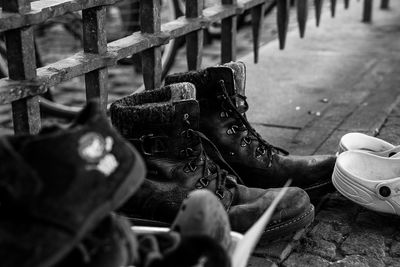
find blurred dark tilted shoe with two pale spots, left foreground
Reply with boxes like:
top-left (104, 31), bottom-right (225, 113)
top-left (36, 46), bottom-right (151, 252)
top-left (0, 102), bottom-right (145, 267)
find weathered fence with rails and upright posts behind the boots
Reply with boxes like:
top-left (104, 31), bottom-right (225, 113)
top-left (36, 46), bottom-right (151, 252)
top-left (0, 0), bottom-right (388, 133)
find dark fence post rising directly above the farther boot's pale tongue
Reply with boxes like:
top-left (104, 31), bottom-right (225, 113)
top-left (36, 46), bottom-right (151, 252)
top-left (221, 0), bottom-right (237, 63)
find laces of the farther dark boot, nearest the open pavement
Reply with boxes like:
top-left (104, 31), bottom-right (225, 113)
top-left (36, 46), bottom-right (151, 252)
top-left (219, 80), bottom-right (289, 166)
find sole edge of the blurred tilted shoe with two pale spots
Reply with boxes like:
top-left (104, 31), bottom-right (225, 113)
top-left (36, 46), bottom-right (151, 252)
top-left (34, 153), bottom-right (146, 267)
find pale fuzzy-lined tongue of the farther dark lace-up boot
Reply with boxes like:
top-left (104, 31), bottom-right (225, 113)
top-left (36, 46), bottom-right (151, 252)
top-left (224, 62), bottom-right (246, 113)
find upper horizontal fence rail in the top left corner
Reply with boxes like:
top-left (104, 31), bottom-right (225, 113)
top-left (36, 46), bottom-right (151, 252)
top-left (0, 0), bottom-right (118, 32)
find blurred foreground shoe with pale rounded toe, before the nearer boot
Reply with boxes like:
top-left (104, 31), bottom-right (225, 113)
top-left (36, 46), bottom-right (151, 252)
top-left (139, 189), bottom-right (233, 267)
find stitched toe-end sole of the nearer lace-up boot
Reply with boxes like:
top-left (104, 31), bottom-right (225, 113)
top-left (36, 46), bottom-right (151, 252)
top-left (260, 204), bottom-right (314, 243)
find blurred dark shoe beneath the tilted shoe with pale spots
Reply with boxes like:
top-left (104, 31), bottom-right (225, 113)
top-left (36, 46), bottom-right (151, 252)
top-left (54, 214), bottom-right (140, 267)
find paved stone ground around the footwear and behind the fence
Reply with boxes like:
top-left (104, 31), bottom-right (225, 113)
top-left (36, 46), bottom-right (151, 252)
top-left (0, 1), bottom-right (400, 267)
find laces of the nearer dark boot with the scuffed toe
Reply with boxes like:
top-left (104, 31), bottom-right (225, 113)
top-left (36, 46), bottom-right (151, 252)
top-left (181, 114), bottom-right (243, 199)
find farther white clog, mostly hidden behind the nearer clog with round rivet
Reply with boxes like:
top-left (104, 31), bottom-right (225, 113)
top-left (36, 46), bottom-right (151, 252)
top-left (338, 133), bottom-right (400, 157)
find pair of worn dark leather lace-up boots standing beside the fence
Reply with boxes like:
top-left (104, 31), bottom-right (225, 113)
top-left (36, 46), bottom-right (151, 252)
top-left (110, 62), bottom-right (336, 240)
